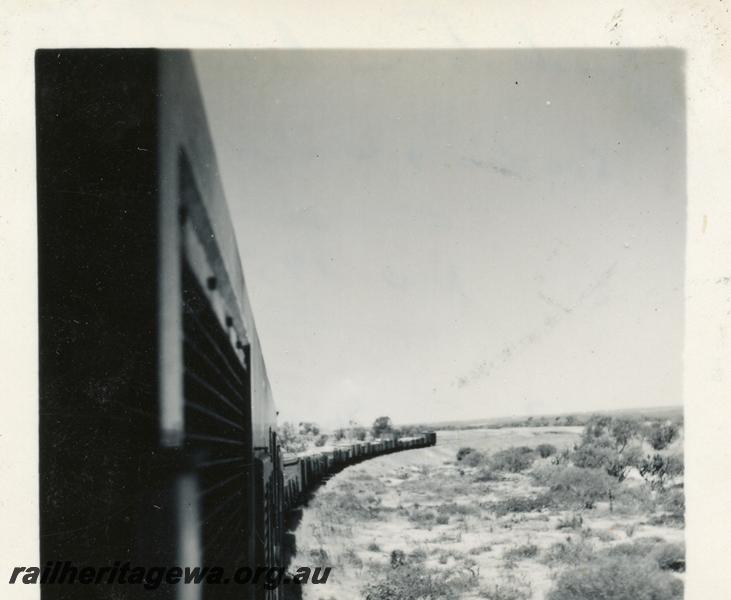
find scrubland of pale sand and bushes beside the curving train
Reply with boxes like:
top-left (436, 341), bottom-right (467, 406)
top-left (298, 415), bottom-right (685, 600)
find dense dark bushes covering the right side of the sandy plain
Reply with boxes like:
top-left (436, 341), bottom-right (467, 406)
top-left (456, 415), bottom-right (685, 600)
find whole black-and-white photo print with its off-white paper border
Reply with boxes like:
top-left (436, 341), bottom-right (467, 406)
top-left (0, 5), bottom-right (731, 600)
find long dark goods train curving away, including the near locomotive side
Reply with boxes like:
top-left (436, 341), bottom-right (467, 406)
top-left (35, 49), bottom-right (436, 600)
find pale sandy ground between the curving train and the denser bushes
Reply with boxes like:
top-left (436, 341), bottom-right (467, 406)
top-left (293, 427), bottom-right (683, 600)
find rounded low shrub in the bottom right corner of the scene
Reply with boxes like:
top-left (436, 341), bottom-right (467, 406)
top-left (546, 556), bottom-right (683, 600)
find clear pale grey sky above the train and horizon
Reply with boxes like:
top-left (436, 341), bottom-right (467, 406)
top-left (194, 49), bottom-right (686, 427)
